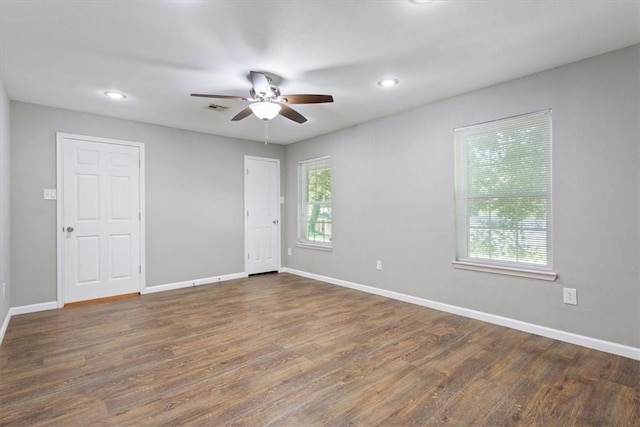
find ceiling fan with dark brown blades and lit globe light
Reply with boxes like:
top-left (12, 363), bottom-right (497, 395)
top-left (191, 71), bottom-right (333, 123)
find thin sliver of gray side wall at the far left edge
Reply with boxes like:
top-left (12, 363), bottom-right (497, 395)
top-left (0, 78), bottom-right (11, 325)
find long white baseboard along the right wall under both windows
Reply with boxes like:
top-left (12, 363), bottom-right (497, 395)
top-left (281, 268), bottom-right (640, 360)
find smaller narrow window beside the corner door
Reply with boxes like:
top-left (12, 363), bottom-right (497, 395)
top-left (298, 157), bottom-right (331, 249)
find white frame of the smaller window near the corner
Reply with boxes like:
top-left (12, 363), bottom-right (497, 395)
top-left (296, 155), bottom-right (333, 251)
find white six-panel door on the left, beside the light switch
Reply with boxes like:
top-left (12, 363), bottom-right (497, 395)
top-left (61, 137), bottom-right (141, 303)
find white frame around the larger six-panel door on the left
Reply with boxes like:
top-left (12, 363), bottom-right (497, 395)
top-left (56, 132), bottom-right (146, 308)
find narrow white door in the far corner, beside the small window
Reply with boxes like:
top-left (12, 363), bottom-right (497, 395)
top-left (244, 156), bottom-right (280, 274)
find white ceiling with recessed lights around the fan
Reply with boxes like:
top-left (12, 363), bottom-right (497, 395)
top-left (0, 0), bottom-right (640, 144)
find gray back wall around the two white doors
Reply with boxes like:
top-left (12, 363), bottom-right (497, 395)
top-left (11, 101), bottom-right (284, 307)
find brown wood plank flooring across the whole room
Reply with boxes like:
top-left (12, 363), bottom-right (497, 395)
top-left (0, 274), bottom-right (640, 426)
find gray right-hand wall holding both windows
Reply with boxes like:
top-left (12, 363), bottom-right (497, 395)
top-left (283, 46), bottom-right (640, 347)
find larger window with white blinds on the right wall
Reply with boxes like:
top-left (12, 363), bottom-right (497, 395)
top-left (454, 110), bottom-right (553, 269)
